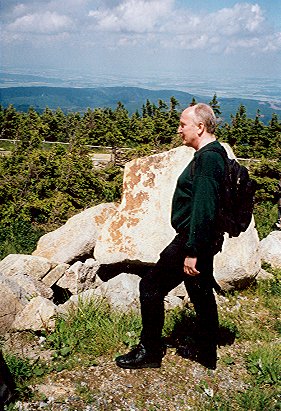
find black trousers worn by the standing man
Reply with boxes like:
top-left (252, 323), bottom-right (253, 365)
top-left (140, 234), bottom-right (218, 350)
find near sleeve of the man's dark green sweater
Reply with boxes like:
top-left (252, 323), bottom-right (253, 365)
top-left (186, 151), bottom-right (224, 257)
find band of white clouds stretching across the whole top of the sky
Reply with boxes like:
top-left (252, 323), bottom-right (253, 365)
top-left (2, 0), bottom-right (281, 54)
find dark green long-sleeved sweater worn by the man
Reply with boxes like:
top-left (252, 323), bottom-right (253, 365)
top-left (171, 141), bottom-right (224, 257)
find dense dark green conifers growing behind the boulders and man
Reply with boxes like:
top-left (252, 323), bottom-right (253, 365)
top-left (0, 95), bottom-right (281, 258)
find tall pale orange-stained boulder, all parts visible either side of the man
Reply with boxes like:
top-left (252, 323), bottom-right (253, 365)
top-left (94, 144), bottom-right (260, 289)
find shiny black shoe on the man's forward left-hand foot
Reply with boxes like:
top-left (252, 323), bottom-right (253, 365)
top-left (115, 344), bottom-right (163, 369)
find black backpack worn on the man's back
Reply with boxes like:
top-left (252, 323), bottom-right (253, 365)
top-left (206, 147), bottom-right (257, 237)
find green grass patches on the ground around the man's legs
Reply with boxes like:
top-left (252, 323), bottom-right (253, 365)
top-left (2, 267), bottom-right (281, 411)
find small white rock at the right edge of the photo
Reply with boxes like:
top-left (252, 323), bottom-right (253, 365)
top-left (260, 231), bottom-right (281, 268)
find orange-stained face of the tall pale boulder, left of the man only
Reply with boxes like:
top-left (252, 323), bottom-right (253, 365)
top-left (94, 147), bottom-right (190, 264)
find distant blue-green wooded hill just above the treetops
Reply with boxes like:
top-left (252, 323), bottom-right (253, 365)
top-left (0, 86), bottom-right (281, 124)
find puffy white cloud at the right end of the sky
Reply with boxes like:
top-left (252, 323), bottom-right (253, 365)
top-left (158, 3), bottom-right (281, 54)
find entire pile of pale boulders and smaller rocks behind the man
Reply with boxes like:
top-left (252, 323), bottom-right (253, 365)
top-left (0, 147), bottom-right (272, 331)
